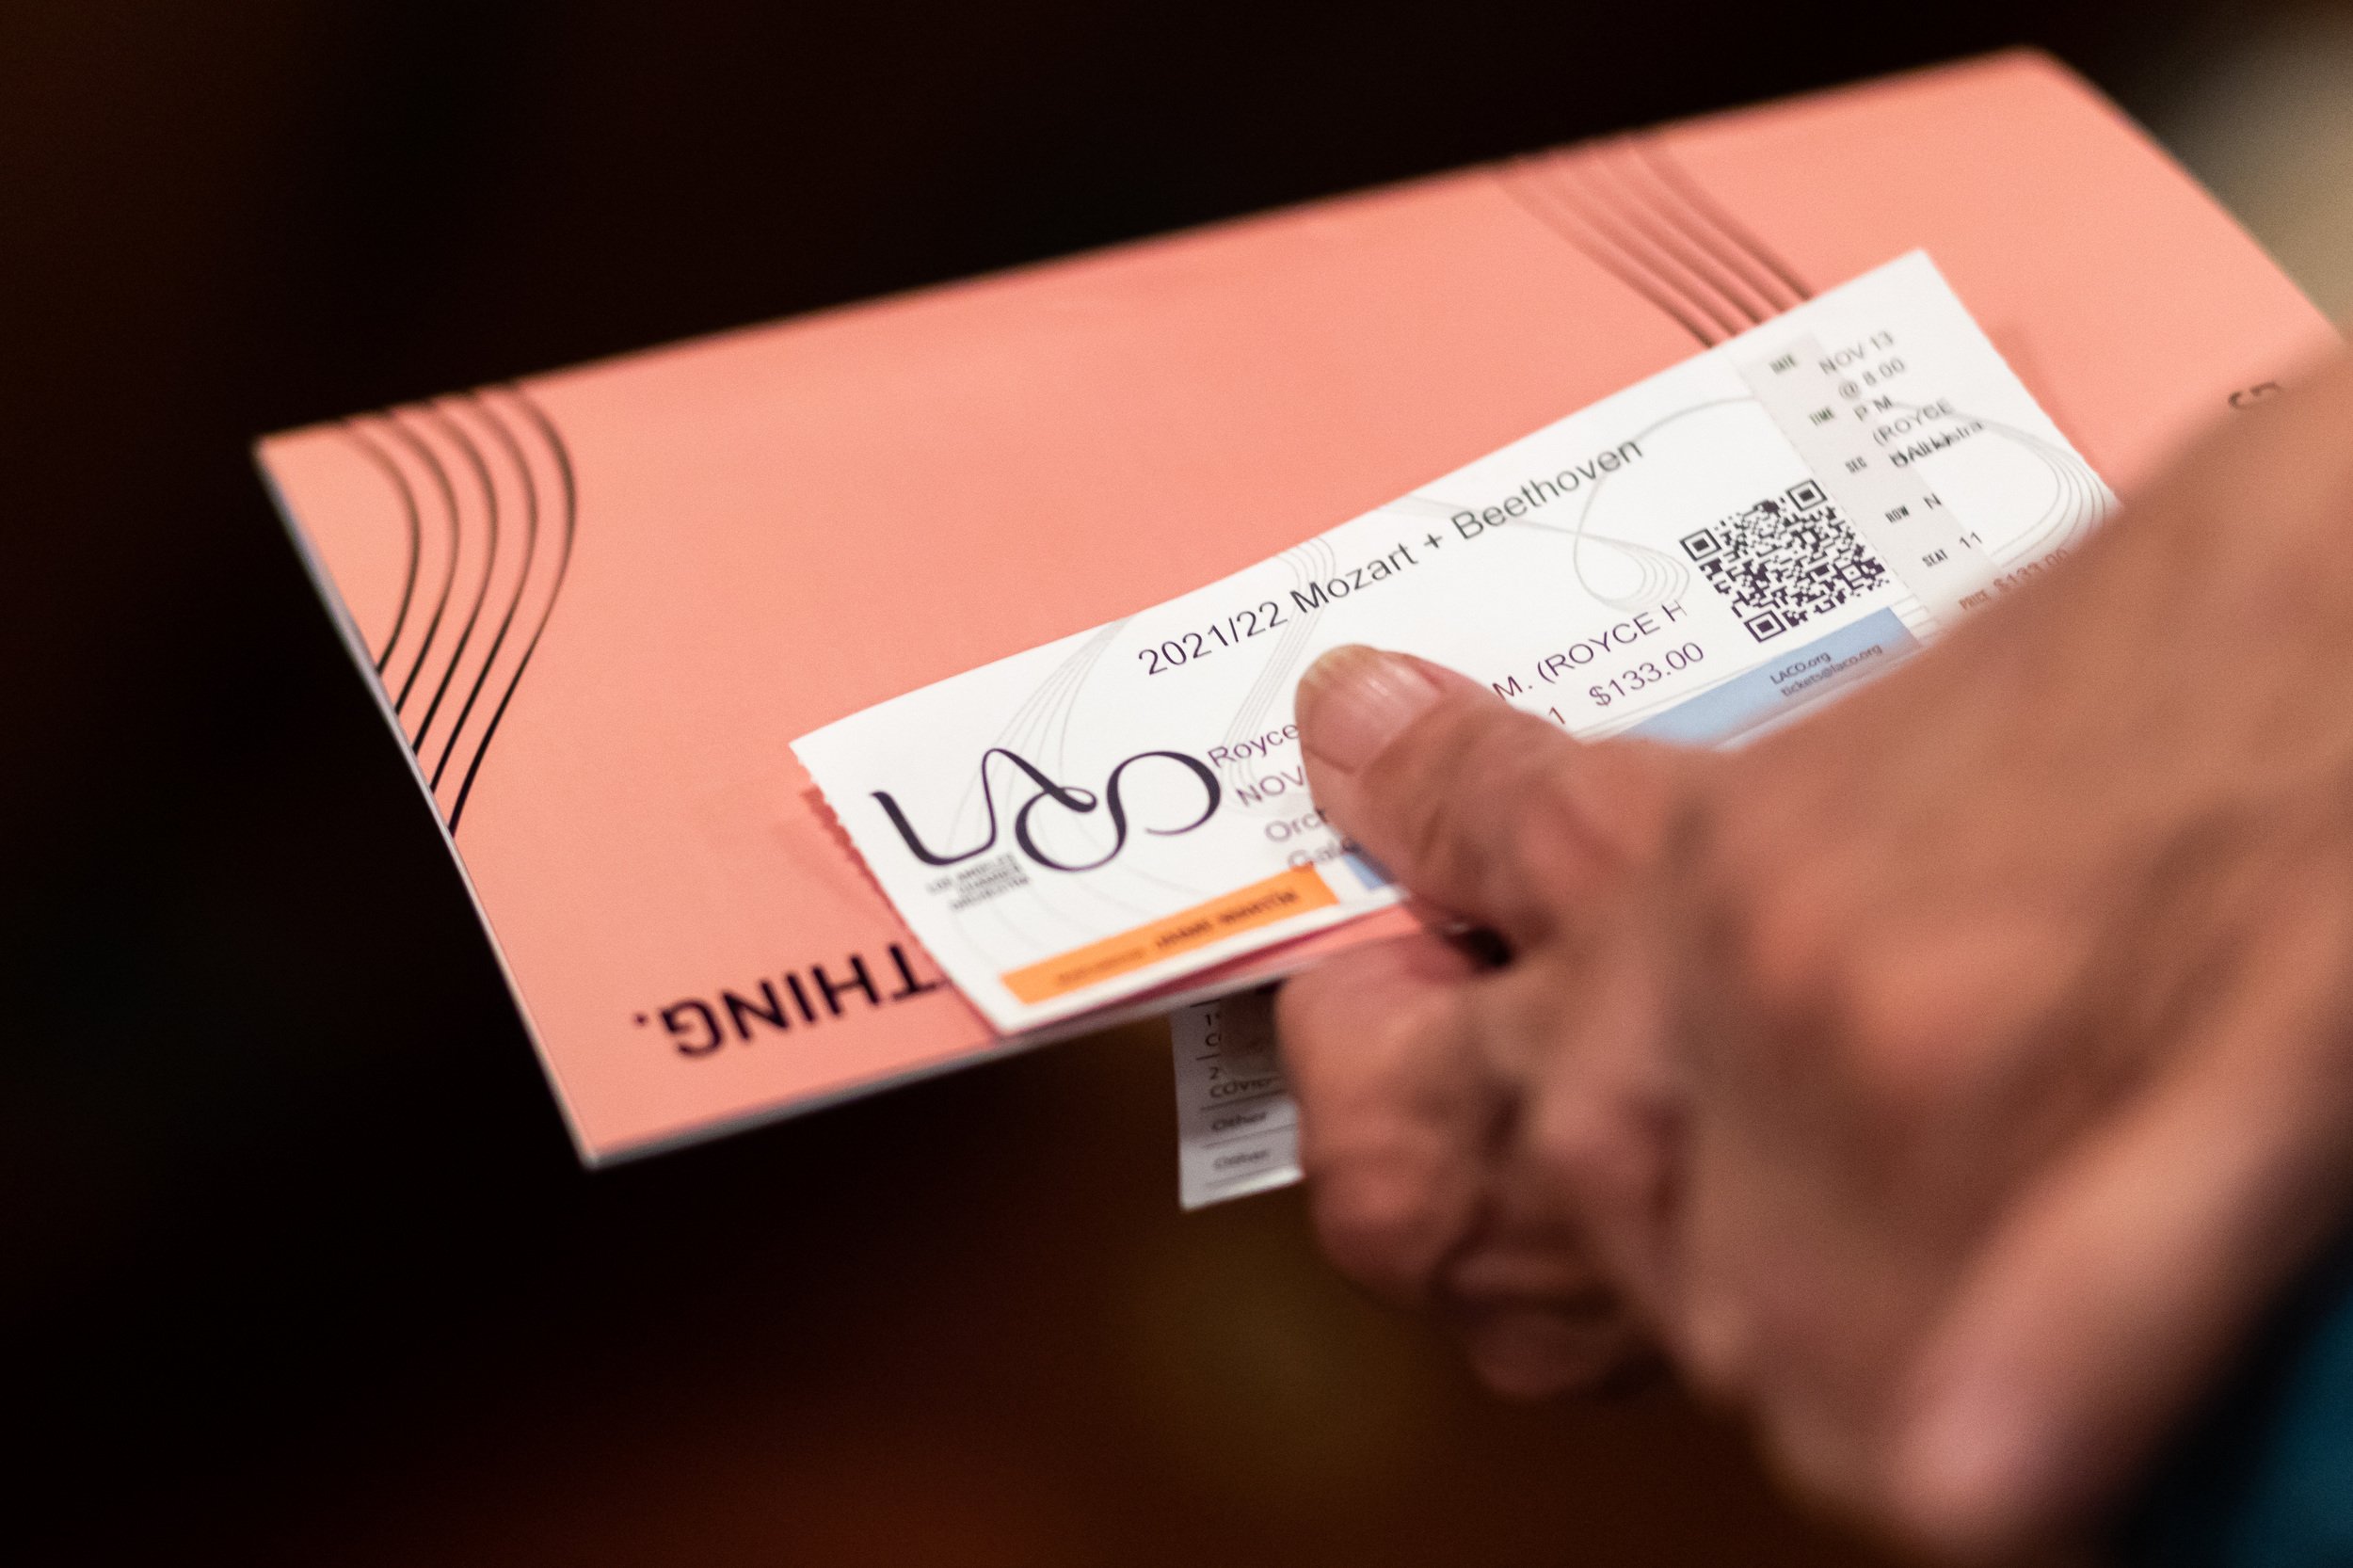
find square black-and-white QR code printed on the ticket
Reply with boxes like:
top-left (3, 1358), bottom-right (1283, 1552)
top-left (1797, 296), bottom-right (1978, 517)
top-left (1683, 480), bottom-right (1887, 643)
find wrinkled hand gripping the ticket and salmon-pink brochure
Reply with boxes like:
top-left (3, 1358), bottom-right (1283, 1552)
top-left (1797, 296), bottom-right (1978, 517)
top-left (1278, 350), bottom-right (2353, 1559)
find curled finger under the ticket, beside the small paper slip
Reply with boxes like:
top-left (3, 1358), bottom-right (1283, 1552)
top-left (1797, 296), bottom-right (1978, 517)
top-left (1275, 933), bottom-right (1504, 1302)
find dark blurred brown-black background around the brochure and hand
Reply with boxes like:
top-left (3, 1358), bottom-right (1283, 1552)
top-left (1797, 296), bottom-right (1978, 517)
top-left (0, 0), bottom-right (2297, 1565)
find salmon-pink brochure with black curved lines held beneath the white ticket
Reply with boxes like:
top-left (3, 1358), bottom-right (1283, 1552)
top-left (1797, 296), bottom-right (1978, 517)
top-left (262, 55), bottom-right (2334, 1160)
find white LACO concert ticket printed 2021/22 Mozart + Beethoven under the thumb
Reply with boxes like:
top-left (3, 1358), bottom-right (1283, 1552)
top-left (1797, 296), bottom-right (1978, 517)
top-left (793, 252), bottom-right (2113, 1033)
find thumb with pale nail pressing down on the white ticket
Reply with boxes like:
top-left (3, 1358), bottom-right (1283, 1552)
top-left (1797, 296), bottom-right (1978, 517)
top-left (1297, 645), bottom-right (1673, 947)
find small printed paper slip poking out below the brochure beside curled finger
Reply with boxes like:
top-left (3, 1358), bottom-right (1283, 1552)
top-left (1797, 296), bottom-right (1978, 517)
top-left (1170, 989), bottom-right (1299, 1210)
